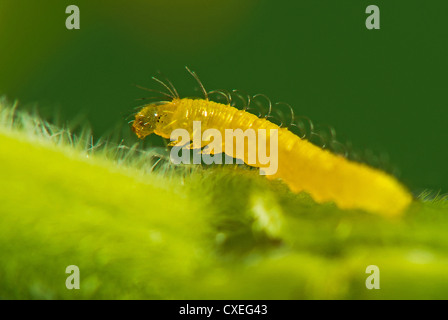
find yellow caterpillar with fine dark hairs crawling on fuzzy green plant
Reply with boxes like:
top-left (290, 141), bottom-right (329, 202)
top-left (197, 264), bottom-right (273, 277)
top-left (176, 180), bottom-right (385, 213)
top-left (132, 68), bottom-right (412, 216)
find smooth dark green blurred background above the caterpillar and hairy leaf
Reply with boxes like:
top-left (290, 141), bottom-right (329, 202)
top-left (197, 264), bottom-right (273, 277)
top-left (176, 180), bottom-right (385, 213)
top-left (0, 0), bottom-right (448, 192)
